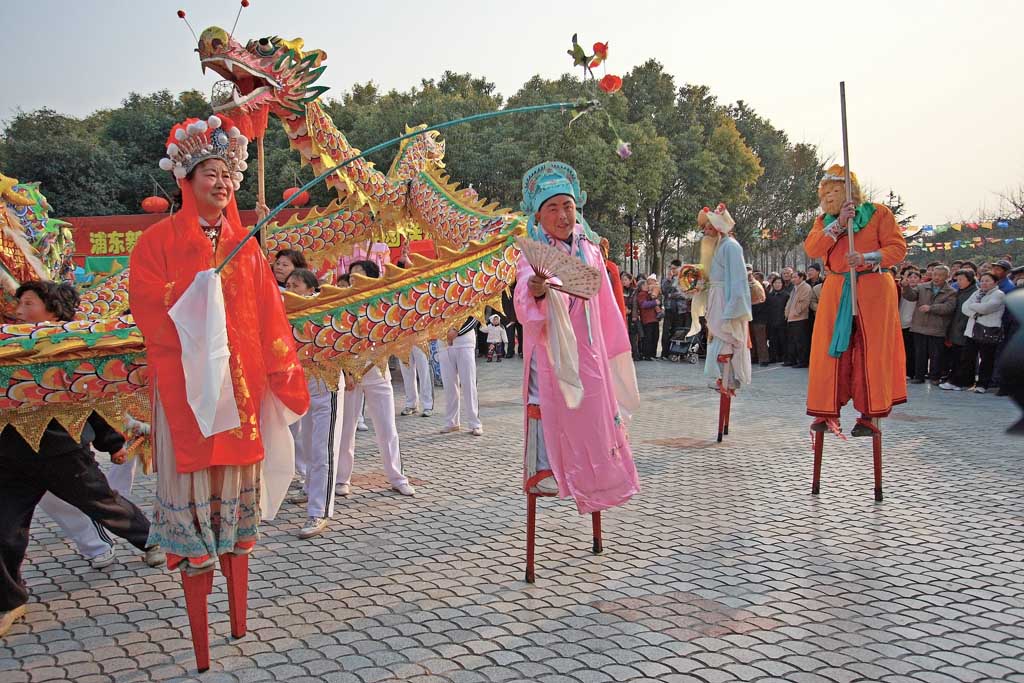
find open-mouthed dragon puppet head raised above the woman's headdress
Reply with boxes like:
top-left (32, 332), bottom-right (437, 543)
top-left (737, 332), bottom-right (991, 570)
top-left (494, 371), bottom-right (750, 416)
top-left (197, 27), bottom-right (328, 126)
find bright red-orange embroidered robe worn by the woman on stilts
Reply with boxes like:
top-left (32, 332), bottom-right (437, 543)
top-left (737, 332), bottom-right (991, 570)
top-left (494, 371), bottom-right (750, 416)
top-left (128, 214), bottom-right (309, 473)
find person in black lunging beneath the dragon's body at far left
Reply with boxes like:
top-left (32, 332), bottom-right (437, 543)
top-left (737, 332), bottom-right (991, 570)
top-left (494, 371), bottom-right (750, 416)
top-left (0, 282), bottom-right (165, 636)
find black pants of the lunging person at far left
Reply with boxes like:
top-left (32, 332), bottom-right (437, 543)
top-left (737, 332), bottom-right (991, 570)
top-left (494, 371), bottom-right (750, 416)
top-left (0, 449), bottom-right (150, 611)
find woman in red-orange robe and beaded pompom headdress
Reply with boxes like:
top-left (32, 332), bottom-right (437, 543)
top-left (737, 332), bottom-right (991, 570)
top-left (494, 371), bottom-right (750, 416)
top-left (129, 117), bottom-right (309, 571)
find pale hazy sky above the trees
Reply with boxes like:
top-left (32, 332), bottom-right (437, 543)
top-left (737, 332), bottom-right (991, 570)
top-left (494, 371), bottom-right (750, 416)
top-left (0, 0), bottom-right (1024, 223)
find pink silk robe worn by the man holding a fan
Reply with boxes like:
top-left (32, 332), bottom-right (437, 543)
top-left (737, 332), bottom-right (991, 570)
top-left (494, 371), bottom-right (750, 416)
top-left (515, 225), bottom-right (640, 514)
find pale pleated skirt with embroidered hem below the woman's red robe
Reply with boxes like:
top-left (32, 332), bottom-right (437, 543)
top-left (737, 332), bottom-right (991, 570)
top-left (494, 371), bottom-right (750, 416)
top-left (150, 387), bottom-right (263, 573)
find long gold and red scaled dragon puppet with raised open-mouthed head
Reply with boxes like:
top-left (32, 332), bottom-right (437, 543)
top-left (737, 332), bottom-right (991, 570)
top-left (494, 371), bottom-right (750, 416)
top-left (0, 28), bottom-right (525, 443)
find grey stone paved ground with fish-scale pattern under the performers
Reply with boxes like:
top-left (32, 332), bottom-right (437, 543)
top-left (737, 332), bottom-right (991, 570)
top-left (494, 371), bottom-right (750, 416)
top-left (0, 360), bottom-right (1024, 683)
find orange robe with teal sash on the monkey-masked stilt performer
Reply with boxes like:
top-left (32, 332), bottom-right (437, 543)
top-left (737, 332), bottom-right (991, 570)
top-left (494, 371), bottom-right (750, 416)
top-left (804, 204), bottom-right (906, 418)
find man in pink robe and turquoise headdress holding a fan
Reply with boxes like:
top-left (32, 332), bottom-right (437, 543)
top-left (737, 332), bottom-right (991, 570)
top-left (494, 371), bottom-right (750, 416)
top-left (515, 162), bottom-right (640, 514)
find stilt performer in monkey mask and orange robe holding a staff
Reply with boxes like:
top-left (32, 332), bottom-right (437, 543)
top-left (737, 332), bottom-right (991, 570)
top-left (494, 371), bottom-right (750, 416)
top-left (804, 165), bottom-right (906, 436)
